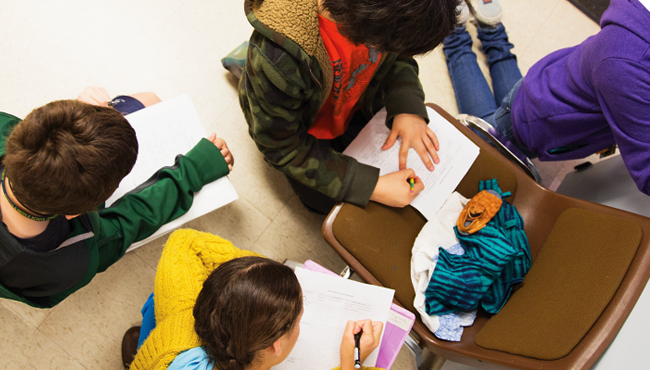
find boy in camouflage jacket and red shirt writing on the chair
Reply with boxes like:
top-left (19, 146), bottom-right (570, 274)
top-left (239, 0), bottom-right (458, 213)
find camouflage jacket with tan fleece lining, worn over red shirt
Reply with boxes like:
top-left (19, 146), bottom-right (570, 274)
top-left (239, 0), bottom-right (428, 206)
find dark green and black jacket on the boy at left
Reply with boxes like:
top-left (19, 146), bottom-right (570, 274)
top-left (0, 112), bottom-right (228, 308)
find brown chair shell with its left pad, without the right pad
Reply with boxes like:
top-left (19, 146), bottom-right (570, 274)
top-left (323, 104), bottom-right (650, 369)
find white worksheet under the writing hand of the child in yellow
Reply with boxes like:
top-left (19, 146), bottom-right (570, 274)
top-left (272, 267), bottom-right (395, 370)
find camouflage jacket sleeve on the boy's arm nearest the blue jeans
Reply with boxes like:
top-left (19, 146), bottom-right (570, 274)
top-left (382, 55), bottom-right (429, 128)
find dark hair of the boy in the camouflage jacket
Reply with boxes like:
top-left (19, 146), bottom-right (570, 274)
top-left (322, 0), bottom-right (462, 56)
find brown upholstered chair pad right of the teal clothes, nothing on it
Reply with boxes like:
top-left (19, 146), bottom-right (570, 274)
top-left (476, 208), bottom-right (642, 360)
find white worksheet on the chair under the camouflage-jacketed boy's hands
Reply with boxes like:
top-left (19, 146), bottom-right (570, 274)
top-left (343, 107), bottom-right (479, 220)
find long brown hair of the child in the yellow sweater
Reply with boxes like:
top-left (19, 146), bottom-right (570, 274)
top-left (194, 257), bottom-right (302, 370)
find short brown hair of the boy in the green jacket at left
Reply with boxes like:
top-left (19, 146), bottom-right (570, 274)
top-left (4, 100), bottom-right (138, 215)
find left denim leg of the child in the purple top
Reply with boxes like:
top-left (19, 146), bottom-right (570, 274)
top-left (442, 27), bottom-right (497, 119)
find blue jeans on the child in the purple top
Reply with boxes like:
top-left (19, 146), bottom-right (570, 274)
top-left (442, 24), bottom-right (535, 158)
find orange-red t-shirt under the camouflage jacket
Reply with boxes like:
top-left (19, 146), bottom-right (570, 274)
top-left (308, 15), bottom-right (381, 139)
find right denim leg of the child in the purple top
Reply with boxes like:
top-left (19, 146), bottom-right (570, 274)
top-left (477, 24), bottom-right (521, 104)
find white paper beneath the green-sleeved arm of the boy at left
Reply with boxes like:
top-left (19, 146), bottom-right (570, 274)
top-left (106, 94), bottom-right (238, 252)
